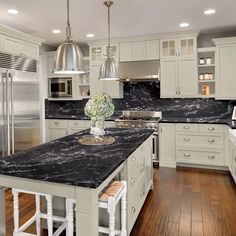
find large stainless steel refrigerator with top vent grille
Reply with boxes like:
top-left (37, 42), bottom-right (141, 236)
top-left (0, 53), bottom-right (40, 157)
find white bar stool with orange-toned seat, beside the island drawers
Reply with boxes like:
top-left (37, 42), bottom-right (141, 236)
top-left (67, 181), bottom-right (127, 236)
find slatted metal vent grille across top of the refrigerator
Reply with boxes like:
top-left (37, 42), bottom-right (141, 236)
top-left (0, 52), bottom-right (37, 72)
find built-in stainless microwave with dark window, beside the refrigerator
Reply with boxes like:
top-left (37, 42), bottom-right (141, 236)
top-left (48, 78), bottom-right (72, 97)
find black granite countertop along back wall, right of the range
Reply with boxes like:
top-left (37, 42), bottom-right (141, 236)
top-left (160, 117), bottom-right (236, 129)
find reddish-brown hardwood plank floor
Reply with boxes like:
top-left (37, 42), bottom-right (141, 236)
top-left (6, 168), bottom-right (236, 236)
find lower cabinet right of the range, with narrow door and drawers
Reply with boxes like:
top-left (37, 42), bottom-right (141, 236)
top-left (159, 123), bottom-right (228, 168)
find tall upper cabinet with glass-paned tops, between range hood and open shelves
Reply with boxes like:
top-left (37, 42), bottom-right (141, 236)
top-left (161, 37), bottom-right (198, 98)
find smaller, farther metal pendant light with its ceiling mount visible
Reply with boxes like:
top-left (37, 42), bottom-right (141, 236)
top-left (98, 1), bottom-right (119, 80)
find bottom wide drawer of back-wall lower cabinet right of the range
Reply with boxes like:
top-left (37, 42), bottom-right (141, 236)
top-left (176, 149), bottom-right (225, 166)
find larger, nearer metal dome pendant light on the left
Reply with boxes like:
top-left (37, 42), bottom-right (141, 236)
top-left (54, 0), bottom-right (84, 74)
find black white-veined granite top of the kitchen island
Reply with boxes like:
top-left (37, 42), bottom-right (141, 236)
top-left (0, 128), bottom-right (154, 188)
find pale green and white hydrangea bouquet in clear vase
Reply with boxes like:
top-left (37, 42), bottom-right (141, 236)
top-left (84, 93), bottom-right (115, 136)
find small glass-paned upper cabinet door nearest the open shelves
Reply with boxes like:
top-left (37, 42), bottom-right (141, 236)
top-left (178, 37), bottom-right (197, 58)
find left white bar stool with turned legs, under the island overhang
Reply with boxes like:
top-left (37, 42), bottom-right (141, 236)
top-left (12, 188), bottom-right (73, 236)
